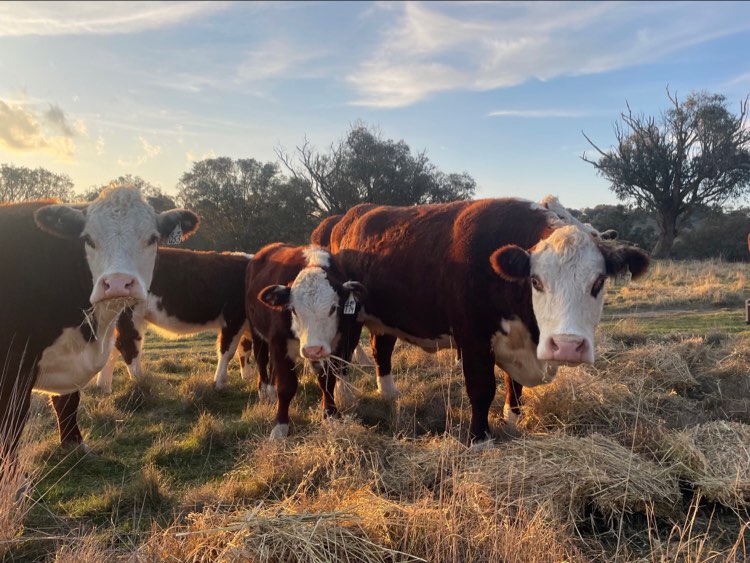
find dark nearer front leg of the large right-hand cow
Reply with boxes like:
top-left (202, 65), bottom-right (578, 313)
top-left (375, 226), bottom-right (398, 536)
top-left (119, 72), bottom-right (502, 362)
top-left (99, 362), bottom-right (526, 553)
top-left (461, 346), bottom-right (495, 442)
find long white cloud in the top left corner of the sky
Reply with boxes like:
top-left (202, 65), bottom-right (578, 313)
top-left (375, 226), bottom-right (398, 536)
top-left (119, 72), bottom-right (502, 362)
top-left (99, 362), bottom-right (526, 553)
top-left (0, 2), bottom-right (228, 37)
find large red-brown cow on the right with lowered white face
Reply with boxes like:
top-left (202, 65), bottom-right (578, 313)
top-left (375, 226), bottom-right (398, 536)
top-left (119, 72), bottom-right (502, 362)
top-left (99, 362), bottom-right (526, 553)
top-left (330, 198), bottom-right (649, 442)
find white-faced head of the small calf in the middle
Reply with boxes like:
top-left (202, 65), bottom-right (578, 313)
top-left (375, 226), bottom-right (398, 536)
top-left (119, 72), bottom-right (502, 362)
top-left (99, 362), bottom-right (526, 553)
top-left (258, 247), bottom-right (366, 361)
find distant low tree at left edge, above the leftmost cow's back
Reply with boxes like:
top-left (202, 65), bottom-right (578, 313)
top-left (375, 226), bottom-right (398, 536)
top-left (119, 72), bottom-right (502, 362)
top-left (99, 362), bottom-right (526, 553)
top-left (0, 164), bottom-right (73, 203)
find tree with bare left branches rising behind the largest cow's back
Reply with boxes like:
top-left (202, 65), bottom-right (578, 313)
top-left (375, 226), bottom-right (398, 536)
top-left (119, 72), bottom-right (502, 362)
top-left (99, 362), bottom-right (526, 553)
top-left (276, 123), bottom-right (476, 217)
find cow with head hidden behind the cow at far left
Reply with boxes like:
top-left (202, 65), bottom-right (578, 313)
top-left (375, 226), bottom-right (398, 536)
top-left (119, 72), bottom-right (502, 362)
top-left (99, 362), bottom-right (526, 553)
top-left (96, 248), bottom-right (252, 393)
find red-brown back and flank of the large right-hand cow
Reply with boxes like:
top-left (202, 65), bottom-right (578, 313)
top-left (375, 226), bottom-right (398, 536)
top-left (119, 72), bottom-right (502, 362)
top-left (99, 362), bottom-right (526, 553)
top-left (331, 199), bottom-right (551, 344)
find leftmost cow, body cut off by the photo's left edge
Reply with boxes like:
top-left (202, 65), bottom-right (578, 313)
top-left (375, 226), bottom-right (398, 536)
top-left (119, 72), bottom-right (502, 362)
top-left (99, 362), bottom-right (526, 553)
top-left (0, 187), bottom-right (199, 462)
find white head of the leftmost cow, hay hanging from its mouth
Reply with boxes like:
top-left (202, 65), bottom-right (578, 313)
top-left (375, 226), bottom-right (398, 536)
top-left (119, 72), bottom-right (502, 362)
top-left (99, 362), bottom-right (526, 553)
top-left (35, 187), bottom-right (199, 305)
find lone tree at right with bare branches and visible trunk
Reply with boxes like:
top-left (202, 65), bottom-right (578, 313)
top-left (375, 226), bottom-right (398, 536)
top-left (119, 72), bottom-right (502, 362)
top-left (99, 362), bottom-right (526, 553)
top-left (581, 89), bottom-right (750, 258)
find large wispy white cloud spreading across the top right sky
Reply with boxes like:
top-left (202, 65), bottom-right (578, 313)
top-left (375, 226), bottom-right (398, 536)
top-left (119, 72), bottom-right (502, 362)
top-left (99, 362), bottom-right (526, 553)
top-left (347, 2), bottom-right (750, 107)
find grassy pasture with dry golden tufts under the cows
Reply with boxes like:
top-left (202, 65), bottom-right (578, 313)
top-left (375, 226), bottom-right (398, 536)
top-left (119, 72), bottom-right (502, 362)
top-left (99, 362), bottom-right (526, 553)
top-left (0, 261), bottom-right (750, 563)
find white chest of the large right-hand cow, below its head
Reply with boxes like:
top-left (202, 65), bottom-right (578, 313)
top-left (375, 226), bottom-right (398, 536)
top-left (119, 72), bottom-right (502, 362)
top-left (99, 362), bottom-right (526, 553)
top-left (492, 319), bottom-right (557, 387)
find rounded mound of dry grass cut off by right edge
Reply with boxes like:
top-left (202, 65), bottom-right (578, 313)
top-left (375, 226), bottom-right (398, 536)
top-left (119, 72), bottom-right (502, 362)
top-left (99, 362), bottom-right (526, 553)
top-left (662, 421), bottom-right (750, 507)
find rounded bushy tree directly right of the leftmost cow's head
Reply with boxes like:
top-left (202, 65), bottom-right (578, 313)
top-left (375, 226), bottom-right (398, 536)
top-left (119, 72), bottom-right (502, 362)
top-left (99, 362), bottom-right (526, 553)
top-left (177, 157), bottom-right (314, 252)
